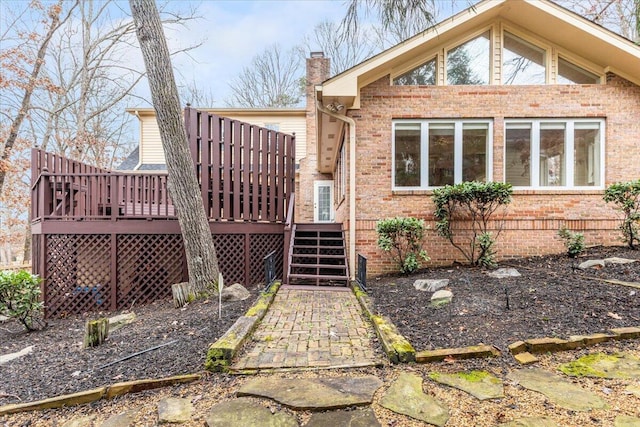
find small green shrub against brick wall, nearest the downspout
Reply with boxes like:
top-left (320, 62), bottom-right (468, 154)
top-left (376, 217), bottom-right (429, 274)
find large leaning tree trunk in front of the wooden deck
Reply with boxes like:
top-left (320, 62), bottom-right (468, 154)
top-left (129, 0), bottom-right (219, 293)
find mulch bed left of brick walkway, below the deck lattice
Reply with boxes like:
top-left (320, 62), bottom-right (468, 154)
top-left (0, 290), bottom-right (258, 406)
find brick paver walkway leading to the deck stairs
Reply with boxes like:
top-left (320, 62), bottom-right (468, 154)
top-left (232, 288), bottom-right (383, 370)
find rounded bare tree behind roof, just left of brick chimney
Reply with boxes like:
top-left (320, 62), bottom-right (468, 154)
top-left (226, 44), bottom-right (304, 108)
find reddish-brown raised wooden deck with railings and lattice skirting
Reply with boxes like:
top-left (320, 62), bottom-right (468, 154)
top-left (31, 108), bottom-right (295, 316)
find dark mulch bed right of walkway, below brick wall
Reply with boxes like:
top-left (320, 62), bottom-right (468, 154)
top-left (368, 247), bottom-right (640, 351)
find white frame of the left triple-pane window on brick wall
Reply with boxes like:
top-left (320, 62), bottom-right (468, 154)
top-left (391, 118), bottom-right (494, 192)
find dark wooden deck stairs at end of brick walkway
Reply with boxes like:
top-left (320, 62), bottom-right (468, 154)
top-left (287, 223), bottom-right (349, 286)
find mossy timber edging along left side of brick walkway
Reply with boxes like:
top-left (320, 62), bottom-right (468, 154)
top-left (204, 282), bottom-right (281, 372)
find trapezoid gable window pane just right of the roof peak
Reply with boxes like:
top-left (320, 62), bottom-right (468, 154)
top-left (502, 31), bottom-right (546, 85)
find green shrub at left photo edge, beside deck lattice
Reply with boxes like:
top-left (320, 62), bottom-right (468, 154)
top-left (0, 270), bottom-right (43, 331)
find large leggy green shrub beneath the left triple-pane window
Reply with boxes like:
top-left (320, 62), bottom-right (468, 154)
top-left (432, 181), bottom-right (513, 267)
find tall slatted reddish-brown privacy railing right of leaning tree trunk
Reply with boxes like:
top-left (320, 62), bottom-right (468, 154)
top-left (185, 108), bottom-right (295, 223)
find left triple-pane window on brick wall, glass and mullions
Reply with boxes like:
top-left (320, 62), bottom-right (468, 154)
top-left (393, 120), bottom-right (492, 189)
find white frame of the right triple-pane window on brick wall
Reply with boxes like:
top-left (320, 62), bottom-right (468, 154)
top-left (502, 117), bottom-right (606, 191)
